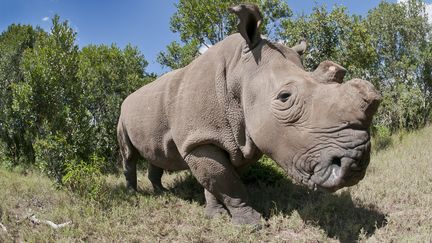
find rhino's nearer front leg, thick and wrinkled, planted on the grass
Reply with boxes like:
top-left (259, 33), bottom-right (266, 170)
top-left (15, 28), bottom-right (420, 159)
top-left (185, 145), bottom-right (261, 225)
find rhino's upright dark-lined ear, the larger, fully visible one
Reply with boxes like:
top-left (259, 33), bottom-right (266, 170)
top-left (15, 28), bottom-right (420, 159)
top-left (229, 4), bottom-right (262, 49)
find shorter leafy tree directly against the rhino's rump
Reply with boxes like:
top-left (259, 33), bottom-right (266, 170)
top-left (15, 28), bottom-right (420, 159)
top-left (77, 45), bottom-right (154, 169)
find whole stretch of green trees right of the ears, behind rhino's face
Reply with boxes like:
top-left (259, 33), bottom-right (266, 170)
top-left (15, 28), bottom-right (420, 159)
top-left (279, 0), bottom-right (432, 132)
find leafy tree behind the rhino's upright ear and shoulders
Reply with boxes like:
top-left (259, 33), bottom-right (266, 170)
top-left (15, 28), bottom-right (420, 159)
top-left (158, 0), bottom-right (292, 69)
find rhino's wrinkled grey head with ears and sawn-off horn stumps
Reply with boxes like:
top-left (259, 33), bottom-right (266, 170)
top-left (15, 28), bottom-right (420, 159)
top-left (231, 5), bottom-right (380, 191)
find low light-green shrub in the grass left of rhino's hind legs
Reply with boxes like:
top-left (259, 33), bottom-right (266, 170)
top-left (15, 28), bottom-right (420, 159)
top-left (62, 155), bottom-right (109, 202)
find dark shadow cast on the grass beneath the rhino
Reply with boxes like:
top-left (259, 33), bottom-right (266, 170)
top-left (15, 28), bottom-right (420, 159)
top-left (166, 167), bottom-right (387, 242)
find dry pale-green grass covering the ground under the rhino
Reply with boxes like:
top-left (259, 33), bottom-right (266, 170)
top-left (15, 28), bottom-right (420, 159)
top-left (0, 127), bottom-right (432, 242)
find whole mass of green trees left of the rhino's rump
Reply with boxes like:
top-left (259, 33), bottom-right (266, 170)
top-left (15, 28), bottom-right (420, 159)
top-left (0, 16), bottom-right (154, 180)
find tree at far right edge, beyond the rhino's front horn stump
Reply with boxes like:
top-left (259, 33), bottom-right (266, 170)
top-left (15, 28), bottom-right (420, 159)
top-left (365, 0), bottom-right (432, 130)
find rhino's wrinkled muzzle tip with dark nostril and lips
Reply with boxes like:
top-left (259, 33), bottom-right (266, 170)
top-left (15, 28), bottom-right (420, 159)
top-left (307, 139), bottom-right (370, 192)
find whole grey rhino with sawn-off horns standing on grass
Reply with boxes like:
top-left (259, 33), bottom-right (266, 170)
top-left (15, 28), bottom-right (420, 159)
top-left (117, 4), bottom-right (380, 225)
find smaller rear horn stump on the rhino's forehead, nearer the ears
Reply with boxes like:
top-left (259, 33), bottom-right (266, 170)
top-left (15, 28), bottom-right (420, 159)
top-left (313, 61), bottom-right (346, 83)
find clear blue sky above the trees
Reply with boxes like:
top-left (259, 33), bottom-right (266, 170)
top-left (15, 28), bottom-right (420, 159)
top-left (0, 0), bottom-right (432, 74)
